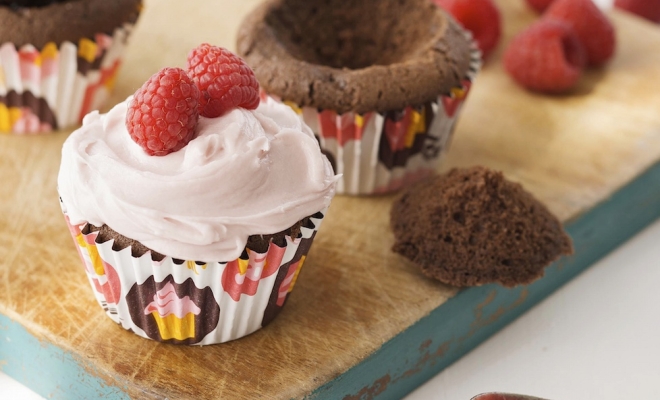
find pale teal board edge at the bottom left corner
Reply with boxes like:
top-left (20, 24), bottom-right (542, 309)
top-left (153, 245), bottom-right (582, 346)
top-left (0, 314), bottom-right (129, 400)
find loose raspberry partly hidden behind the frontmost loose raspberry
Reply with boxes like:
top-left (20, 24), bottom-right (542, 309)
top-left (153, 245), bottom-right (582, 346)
top-left (543, 0), bottom-right (616, 67)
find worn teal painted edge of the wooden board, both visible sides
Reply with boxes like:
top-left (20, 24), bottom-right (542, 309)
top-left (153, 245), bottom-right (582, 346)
top-left (0, 163), bottom-right (660, 400)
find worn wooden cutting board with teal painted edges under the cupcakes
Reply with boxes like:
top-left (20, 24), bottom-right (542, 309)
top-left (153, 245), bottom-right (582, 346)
top-left (0, 0), bottom-right (660, 399)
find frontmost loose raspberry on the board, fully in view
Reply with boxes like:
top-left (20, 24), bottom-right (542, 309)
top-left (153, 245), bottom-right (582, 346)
top-left (504, 19), bottom-right (586, 93)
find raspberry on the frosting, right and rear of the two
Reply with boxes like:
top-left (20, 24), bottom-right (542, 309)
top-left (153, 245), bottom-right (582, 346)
top-left (188, 43), bottom-right (259, 118)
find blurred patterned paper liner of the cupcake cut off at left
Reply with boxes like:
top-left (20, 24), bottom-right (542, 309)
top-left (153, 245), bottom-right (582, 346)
top-left (0, 23), bottom-right (133, 134)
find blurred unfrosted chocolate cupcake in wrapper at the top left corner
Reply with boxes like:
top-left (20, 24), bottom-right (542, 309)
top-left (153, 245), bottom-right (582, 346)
top-left (0, 0), bottom-right (142, 134)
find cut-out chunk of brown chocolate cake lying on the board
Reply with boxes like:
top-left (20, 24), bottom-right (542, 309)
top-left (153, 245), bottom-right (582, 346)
top-left (391, 167), bottom-right (573, 287)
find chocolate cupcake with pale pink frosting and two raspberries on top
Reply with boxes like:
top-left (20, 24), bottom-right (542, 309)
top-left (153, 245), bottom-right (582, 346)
top-left (58, 46), bottom-right (337, 345)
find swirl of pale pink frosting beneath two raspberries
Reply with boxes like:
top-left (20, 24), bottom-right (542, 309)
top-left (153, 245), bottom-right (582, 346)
top-left (58, 97), bottom-right (338, 261)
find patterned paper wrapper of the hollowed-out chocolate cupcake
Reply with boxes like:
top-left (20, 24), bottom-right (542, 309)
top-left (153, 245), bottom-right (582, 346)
top-left (262, 36), bottom-right (481, 195)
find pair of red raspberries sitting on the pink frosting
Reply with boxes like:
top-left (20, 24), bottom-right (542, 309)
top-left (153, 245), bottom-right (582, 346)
top-left (126, 44), bottom-right (259, 156)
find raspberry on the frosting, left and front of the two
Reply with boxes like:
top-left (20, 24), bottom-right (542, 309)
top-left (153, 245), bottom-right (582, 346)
top-left (126, 68), bottom-right (199, 156)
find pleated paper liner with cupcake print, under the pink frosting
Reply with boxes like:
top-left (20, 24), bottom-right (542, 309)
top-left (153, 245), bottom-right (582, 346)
top-left (65, 210), bottom-right (325, 345)
